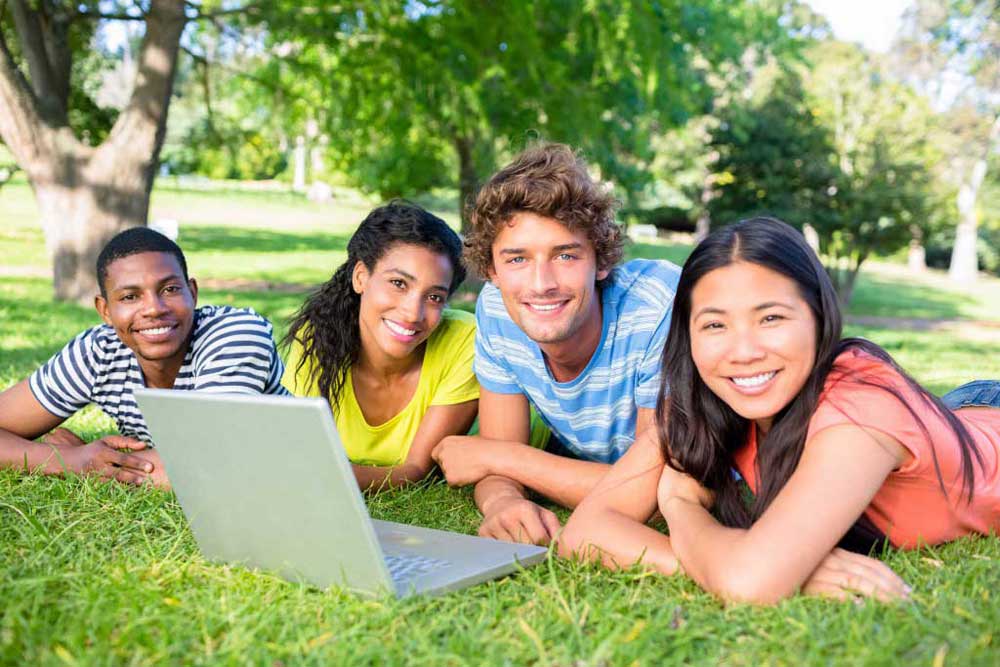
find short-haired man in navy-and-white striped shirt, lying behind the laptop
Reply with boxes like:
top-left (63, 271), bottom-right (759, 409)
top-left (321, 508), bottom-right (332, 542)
top-left (0, 227), bottom-right (287, 487)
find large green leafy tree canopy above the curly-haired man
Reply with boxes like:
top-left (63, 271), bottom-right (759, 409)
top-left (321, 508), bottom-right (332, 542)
top-left (256, 0), bottom-right (777, 230)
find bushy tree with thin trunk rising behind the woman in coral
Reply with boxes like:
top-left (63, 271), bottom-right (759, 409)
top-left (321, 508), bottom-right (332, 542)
top-left (709, 41), bottom-right (934, 306)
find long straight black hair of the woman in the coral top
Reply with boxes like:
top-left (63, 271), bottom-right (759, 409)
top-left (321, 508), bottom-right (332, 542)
top-left (656, 217), bottom-right (984, 528)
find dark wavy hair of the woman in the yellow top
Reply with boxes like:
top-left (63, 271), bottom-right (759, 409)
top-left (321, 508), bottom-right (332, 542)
top-left (282, 200), bottom-right (465, 410)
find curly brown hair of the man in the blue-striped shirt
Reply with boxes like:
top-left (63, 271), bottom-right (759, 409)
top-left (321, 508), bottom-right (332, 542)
top-left (465, 143), bottom-right (625, 279)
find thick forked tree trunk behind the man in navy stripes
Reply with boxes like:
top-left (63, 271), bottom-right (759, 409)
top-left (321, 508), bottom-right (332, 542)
top-left (0, 0), bottom-right (187, 304)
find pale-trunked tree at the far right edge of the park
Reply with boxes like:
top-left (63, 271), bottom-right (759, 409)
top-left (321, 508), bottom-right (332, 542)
top-left (896, 0), bottom-right (1000, 283)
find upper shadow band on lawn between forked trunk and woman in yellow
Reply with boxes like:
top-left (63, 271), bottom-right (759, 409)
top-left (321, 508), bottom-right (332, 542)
top-left (179, 226), bottom-right (349, 253)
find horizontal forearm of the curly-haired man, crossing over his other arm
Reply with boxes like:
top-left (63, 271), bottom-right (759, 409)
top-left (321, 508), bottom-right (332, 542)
top-left (490, 441), bottom-right (611, 509)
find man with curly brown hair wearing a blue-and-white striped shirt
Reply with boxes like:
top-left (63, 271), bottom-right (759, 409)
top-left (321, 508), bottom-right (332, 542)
top-left (433, 144), bottom-right (680, 544)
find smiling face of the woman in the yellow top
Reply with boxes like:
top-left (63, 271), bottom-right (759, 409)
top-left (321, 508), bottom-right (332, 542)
top-left (352, 244), bottom-right (453, 362)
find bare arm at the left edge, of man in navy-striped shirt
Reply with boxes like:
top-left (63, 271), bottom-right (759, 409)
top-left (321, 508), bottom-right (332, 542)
top-left (0, 380), bottom-right (152, 484)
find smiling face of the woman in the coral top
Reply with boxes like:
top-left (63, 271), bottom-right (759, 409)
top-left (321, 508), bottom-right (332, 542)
top-left (689, 262), bottom-right (816, 432)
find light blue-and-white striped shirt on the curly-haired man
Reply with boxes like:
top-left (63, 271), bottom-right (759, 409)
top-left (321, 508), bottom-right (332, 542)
top-left (473, 259), bottom-right (680, 463)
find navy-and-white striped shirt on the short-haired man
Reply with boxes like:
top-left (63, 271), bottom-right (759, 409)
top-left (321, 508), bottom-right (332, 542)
top-left (28, 306), bottom-right (288, 443)
